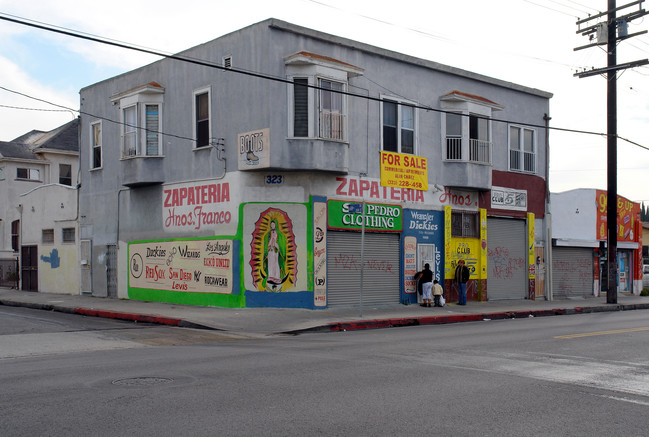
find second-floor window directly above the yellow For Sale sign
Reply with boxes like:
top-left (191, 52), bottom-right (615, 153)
top-left (381, 99), bottom-right (416, 154)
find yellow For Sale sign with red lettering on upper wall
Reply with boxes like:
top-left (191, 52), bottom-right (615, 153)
top-left (381, 152), bottom-right (428, 191)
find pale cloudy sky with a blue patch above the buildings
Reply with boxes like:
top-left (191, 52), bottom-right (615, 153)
top-left (0, 0), bottom-right (649, 203)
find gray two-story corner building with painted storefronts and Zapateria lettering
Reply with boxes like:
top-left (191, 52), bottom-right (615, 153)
top-left (80, 19), bottom-right (551, 309)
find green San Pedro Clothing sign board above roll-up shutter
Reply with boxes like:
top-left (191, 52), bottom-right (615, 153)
top-left (327, 200), bottom-right (403, 232)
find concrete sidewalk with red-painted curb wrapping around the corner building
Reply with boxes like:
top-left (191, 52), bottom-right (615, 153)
top-left (0, 288), bottom-right (649, 336)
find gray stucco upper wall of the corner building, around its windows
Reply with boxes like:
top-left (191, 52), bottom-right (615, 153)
top-left (80, 20), bottom-right (551, 296)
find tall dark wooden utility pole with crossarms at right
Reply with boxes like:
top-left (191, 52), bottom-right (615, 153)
top-left (575, 0), bottom-right (649, 304)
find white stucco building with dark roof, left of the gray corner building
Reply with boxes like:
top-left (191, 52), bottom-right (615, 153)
top-left (0, 119), bottom-right (80, 294)
